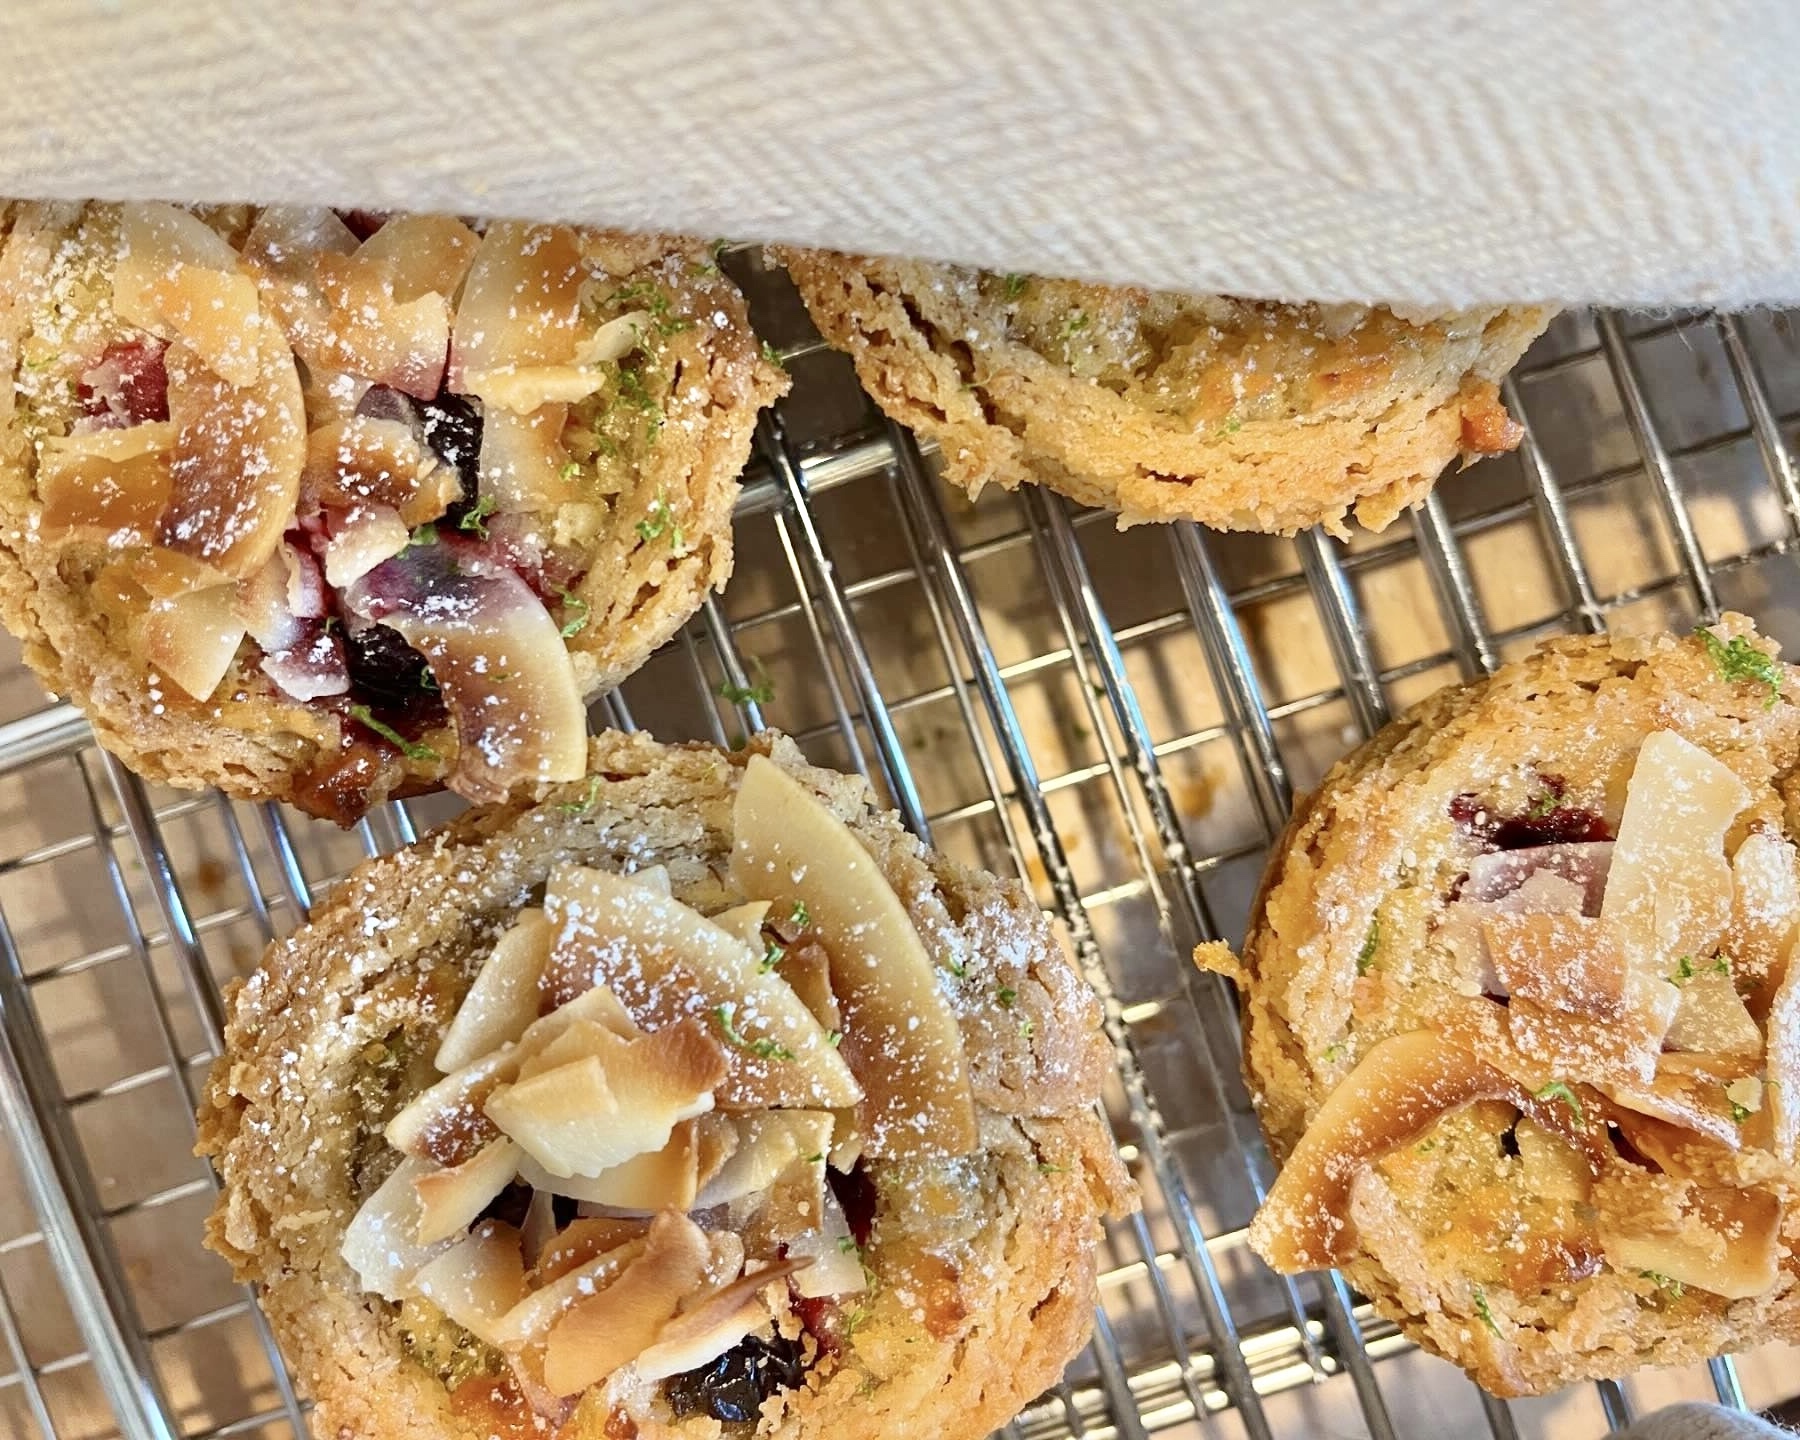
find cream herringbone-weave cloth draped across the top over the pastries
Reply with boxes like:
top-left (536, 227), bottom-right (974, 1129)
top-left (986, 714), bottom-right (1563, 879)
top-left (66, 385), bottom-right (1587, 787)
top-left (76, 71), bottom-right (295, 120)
top-left (0, 0), bottom-right (1800, 304)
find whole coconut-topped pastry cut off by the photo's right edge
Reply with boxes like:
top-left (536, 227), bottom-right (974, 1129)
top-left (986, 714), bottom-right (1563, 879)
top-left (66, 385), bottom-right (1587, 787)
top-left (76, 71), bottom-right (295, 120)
top-left (1197, 616), bottom-right (1800, 1395)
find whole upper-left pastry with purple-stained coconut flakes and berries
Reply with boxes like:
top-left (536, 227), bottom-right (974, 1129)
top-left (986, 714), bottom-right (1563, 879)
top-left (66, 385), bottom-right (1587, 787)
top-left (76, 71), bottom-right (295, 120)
top-left (0, 202), bottom-right (787, 824)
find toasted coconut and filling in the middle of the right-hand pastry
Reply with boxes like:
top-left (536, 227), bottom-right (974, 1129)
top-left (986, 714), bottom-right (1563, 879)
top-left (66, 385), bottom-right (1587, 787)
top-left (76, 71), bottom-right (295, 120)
top-left (1256, 731), bottom-right (1800, 1334)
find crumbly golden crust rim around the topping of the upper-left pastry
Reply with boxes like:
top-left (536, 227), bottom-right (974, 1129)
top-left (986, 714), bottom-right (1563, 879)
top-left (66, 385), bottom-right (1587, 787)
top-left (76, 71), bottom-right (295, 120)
top-left (0, 202), bottom-right (787, 823)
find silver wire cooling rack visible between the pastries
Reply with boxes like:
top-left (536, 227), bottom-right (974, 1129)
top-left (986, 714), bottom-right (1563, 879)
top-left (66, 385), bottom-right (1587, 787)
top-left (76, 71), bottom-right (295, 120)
top-left (0, 259), bottom-right (1800, 1440)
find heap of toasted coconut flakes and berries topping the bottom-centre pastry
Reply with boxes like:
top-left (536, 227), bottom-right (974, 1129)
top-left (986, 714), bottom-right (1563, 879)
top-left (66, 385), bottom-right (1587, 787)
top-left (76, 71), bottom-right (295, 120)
top-left (342, 756), bottom-right (977, 1424)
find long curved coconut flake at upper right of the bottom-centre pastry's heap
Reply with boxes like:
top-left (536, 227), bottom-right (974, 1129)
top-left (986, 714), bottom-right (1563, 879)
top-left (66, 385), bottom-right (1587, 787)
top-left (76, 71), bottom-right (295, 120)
top-left (731, 756), bottom-right (977, 1157)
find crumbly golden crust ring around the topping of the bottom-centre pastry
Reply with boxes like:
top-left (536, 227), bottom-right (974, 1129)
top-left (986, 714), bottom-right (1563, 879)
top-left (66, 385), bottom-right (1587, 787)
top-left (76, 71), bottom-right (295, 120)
top-left (200, 733), bottom-right (1136, 1440)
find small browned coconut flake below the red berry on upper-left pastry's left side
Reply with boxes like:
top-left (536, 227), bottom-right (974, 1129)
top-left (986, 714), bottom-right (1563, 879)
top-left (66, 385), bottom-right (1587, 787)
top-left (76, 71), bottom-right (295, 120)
top-left (38, 421), bottom-right (175, 545)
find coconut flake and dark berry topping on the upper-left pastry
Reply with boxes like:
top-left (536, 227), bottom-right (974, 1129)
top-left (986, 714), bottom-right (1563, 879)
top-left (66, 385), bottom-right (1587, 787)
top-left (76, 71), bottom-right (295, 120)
top-left (22, 203), bottom-right (716, 819)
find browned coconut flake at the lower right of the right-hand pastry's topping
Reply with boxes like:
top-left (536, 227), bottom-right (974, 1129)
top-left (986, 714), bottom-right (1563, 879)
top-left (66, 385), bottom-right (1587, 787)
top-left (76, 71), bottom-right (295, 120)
top-left (1600, 1190), bottom-right (1782, 1300)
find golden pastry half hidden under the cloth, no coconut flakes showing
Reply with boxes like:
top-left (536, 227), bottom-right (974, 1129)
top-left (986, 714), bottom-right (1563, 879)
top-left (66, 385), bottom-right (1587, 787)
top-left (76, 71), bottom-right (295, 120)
top-left (778, 250), bottom-right (1553, 535)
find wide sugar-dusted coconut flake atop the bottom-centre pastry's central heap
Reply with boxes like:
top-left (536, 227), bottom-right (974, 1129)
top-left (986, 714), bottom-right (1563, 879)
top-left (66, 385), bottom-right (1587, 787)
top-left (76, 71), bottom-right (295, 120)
top-left (544, 864), bottom-right (860, 1107)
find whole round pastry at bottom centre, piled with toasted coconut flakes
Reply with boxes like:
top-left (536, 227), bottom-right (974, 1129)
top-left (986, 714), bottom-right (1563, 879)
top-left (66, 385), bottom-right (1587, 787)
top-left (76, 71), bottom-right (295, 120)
top-left (202, 734), bottom-right (1136, 1440)
